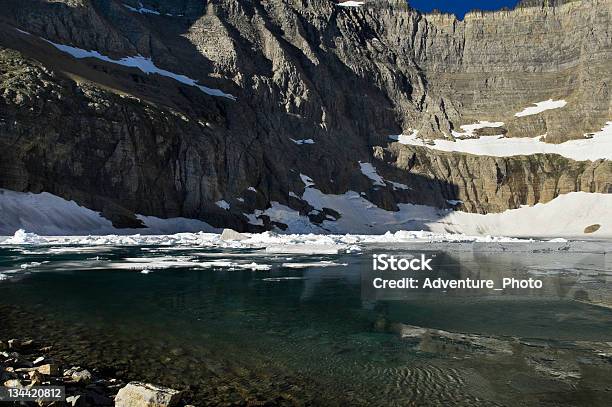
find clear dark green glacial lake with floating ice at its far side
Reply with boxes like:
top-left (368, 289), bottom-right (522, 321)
top-left (0, 243), bottom-right (612, 406)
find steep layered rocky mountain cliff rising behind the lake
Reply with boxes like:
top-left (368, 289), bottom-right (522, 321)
top-left (0, 0), bottom-right (612, 231)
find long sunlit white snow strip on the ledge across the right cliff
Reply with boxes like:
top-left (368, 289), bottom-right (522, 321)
top-left (390, 121), bottom-right (612, 161)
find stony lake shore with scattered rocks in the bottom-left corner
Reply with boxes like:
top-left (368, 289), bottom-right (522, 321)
top-left (0, 339), bottom-right (189, 407)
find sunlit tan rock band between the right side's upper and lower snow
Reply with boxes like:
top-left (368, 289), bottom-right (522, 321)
top-left (375, 143), bottom-right (612, 213)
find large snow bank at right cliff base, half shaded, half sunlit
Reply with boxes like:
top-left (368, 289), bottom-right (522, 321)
top-left (290, 188), bottom-right (612, 237)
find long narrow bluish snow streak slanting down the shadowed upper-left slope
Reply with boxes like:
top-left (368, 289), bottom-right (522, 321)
top-left (43, 38), bottom-right (236, 100)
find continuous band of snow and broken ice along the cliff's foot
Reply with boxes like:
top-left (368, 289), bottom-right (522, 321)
top-left (0, 187), bottom-right (612, 244)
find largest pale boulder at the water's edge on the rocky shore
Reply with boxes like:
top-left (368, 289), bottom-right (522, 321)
top-left (115, 382), bottom-right (181, 407)
